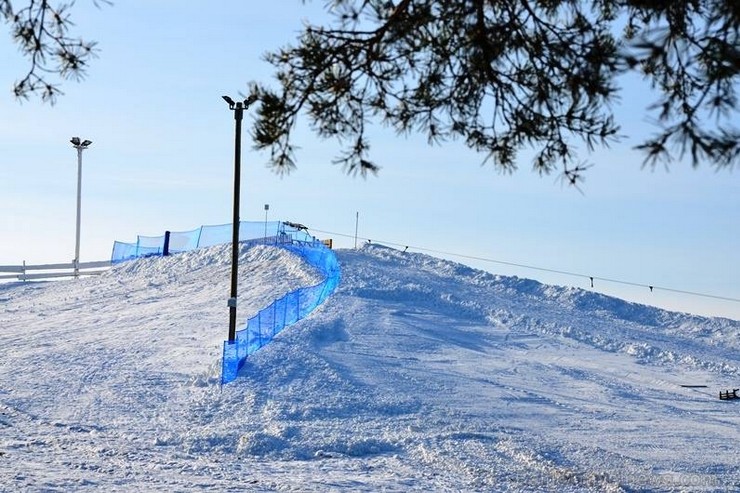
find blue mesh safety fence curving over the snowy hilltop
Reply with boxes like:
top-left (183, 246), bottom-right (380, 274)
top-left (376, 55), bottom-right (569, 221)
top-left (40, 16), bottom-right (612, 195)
top-left (111, 221), bottom-right (340, 384)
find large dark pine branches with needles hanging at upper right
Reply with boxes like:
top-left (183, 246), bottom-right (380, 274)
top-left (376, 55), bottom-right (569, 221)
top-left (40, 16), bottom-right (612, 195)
top-left (250, 0), bottom-right (740, 183)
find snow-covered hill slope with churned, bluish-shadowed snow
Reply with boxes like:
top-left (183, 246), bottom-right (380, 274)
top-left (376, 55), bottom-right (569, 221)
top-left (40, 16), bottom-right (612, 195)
top-left (0, 246), bottom-right (740, 492)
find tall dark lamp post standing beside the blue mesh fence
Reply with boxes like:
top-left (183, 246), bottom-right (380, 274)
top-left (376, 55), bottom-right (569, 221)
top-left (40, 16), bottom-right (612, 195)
top-left (221, 94), bottom-right (257, 342)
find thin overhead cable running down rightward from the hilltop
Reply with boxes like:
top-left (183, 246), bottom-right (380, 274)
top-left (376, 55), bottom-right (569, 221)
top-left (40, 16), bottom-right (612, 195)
top-left (304, 228), bottom-right (740, 303)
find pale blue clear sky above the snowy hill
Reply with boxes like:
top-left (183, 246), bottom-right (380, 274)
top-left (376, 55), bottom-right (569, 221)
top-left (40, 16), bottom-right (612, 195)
top-left (0, 0), bottom-right (740, 319)
